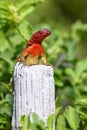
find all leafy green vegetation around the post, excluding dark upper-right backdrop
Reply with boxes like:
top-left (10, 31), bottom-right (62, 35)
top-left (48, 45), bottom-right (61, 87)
top-left (0, 0), bottom-right (87, 130)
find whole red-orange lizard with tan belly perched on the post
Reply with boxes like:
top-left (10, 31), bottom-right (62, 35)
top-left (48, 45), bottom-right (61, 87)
top-left (18, 28), bottom-right (51, 65)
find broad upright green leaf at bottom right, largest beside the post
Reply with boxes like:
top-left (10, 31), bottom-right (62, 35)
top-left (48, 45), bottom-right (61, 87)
top-left (64, 106), bottom-right (80, 130)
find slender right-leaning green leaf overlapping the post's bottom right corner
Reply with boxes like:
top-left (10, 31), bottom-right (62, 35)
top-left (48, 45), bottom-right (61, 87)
top-left (47, 107), bottom-right (61, 130)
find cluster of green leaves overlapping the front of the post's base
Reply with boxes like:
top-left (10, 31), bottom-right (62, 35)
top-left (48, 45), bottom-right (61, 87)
top-left (19, 108), bottom-right (61, 130)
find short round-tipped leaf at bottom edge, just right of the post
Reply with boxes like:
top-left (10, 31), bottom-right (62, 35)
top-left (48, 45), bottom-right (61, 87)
top-left (56, 115), bottom-right (66, 130)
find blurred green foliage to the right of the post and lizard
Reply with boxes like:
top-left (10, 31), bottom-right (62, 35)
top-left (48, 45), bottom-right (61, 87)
top-left (41, 22), bottom-right (87, 130)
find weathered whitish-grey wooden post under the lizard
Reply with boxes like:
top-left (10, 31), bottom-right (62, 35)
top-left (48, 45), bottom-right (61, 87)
top-left (12, 62), bottom-right (55, 130)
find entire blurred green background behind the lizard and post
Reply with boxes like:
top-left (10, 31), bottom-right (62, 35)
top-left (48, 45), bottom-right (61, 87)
top-left (0, 0), bottom-right (87, 130)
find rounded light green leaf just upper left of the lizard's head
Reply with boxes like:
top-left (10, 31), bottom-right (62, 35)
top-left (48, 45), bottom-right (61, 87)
top-left (17, 21), bottom-right (32, 41)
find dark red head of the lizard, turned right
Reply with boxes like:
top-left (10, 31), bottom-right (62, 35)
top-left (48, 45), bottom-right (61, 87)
top-left (29, 28), bottom-right (51, 44)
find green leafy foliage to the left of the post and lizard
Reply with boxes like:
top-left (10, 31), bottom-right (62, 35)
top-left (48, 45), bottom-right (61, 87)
top-left (0, 0), bottom-right (43, 130)
